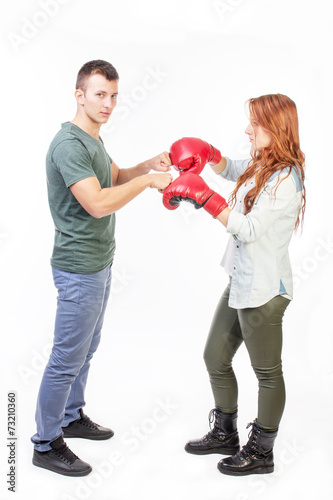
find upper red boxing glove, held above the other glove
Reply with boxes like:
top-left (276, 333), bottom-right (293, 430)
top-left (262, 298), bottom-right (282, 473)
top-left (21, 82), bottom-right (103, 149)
top-left (170, 137), bottom-right (222, 175)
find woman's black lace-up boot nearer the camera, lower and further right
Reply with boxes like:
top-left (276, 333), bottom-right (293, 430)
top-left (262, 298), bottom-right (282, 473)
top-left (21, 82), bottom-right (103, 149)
top-left (217, 420), bottom-right (277, 476)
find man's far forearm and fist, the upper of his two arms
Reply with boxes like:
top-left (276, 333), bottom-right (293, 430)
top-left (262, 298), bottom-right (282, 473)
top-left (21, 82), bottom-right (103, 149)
top-left (111, 152), bottom-right (171, 186)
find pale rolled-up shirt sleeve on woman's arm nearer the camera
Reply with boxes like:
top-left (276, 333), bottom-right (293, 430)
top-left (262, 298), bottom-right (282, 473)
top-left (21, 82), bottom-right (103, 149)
top-left (227, 175), bottom-right (296, 242)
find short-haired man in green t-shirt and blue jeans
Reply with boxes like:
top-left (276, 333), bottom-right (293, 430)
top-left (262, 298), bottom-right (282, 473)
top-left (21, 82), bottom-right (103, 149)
top-left (32, 60), bottom-right (172, 476)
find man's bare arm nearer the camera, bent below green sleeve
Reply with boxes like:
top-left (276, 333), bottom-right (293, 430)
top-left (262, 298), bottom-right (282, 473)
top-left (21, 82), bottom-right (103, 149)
top-left (69, 173), bottom-right (172, 219)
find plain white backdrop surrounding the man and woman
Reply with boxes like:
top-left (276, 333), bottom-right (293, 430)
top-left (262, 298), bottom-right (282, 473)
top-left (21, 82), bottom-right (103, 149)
top-left (0, 0), bottom-right (333, 500)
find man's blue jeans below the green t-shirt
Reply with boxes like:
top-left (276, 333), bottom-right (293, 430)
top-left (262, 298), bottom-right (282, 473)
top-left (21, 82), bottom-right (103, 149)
top-left (31, 265), bottom-right (111, 451)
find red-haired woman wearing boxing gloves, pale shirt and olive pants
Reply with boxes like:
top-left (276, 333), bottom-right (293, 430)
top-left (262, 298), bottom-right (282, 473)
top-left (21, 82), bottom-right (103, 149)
top-left (163, 94), bottom-right (305, 475)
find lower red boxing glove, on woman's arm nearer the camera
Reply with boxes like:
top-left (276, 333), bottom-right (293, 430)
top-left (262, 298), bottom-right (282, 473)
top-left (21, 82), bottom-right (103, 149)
top-left (163, 173), bottom-right (228, 218)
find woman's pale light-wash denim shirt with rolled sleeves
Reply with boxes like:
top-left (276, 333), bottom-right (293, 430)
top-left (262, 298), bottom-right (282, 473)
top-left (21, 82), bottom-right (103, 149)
top-left (220, 158), bottom-right (302, 309)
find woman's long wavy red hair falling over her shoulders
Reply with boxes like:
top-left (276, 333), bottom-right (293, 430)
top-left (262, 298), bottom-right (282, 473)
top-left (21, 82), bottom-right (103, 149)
top-left (230, 94), bottom-right (306, 229)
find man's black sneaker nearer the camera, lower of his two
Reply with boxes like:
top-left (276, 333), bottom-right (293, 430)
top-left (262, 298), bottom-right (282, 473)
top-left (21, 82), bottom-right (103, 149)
top-left (32, 436), bottom-right (92, 476)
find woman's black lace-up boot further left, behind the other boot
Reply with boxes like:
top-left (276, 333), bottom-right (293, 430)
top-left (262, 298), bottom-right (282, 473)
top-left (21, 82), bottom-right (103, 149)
top-left (185, 408), bottom-right (239, 455)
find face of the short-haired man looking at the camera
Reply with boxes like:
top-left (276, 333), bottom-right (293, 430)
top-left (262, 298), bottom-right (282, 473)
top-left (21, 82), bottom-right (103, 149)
top-left (77, 74), bottom-right (118, 125)
